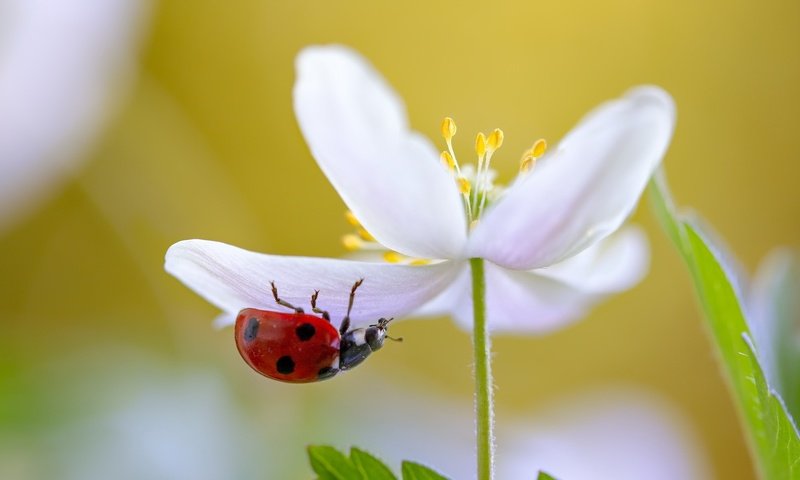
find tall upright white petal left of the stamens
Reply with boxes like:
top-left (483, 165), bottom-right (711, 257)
top-left (294, 46), bottom-right (466, 258)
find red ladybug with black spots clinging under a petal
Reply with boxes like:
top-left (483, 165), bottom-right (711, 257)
top-left (234, 278), bottom-right (402, 383)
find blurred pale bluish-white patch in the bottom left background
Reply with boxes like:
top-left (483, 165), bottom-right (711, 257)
top-left (53, 372), bottom-right (260, 480)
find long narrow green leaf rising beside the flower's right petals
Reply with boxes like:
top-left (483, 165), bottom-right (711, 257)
top-left (650, 173), bottom-right (800, 480)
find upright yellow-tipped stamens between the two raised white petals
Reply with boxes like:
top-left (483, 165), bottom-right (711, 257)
top-left (441, 117), bottom-right (547, 229)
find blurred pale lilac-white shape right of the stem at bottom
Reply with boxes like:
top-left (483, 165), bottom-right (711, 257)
top-left (497, 387), bottom-right (713, 480)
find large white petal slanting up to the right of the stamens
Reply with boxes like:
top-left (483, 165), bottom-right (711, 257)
top-left (468, 87), bottom-right (675, 270)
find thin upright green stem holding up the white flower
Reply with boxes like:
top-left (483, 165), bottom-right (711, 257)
top-left (469, 258), bottom-right (494, 480)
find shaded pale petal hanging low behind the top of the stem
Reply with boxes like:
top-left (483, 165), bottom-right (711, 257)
top-left (412, 262), bottom-right (620, 334)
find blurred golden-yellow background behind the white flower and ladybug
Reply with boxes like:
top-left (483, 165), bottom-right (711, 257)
top-left (0, 0), bottom-right (800, 479)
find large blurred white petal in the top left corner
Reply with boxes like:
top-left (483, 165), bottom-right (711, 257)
top-left (0, 0), bottom-right (149, 230)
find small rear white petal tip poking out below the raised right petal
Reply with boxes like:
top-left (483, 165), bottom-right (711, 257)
top-left (536, 225), bottom-right (650, 294)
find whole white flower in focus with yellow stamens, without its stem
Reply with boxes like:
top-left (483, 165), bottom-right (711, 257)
top-left (165, 46), bottom-right (674, 332)
